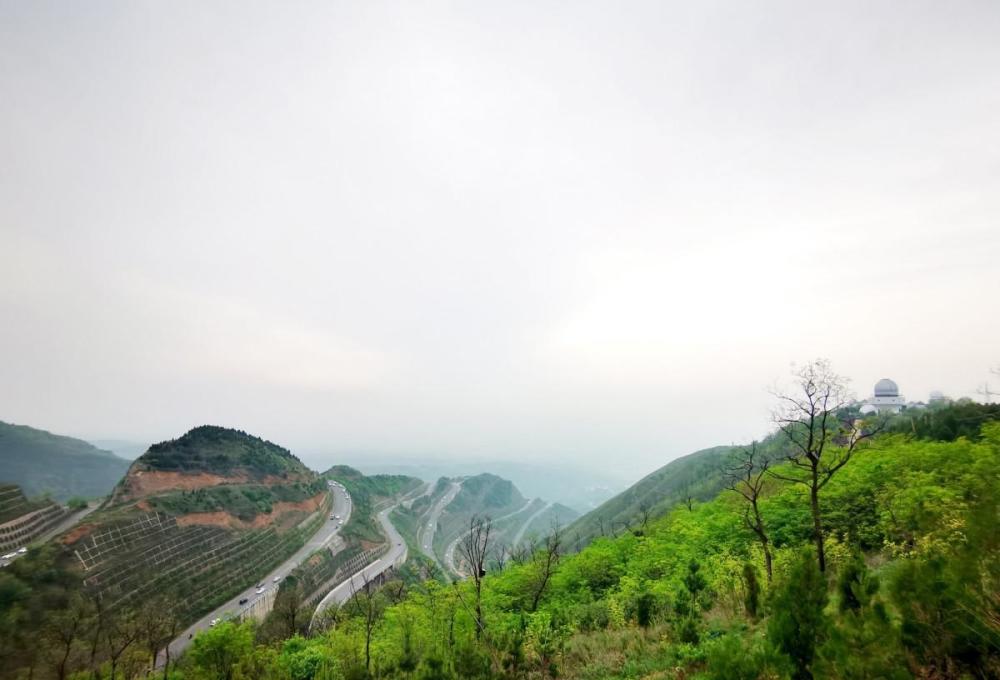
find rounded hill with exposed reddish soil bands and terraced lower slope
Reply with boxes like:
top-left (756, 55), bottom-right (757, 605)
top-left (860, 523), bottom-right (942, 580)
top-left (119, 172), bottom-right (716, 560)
top-left (61, 426), bottom-right (329, 619)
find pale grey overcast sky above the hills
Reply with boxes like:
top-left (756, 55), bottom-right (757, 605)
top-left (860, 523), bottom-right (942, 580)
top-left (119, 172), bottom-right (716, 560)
top-left (0, 0), bottom-right (1000, 476)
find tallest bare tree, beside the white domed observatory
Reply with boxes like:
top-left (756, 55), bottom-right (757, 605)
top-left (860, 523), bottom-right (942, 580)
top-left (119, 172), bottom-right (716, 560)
top-left (770, 359), bottom-right (884, 571)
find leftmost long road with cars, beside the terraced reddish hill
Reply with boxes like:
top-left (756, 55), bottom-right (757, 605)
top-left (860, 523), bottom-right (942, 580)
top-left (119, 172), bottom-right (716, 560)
top-left (157, 482), bottom-right (352, 667)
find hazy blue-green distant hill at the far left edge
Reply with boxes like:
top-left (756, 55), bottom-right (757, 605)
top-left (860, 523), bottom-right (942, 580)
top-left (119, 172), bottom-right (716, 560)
top-left (0, 422), bottom-right (129, 501)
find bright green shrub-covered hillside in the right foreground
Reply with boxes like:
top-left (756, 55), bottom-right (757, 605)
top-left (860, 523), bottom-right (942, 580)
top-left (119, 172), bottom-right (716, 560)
top-left (156, 406), bottom-right (1000, 680)
